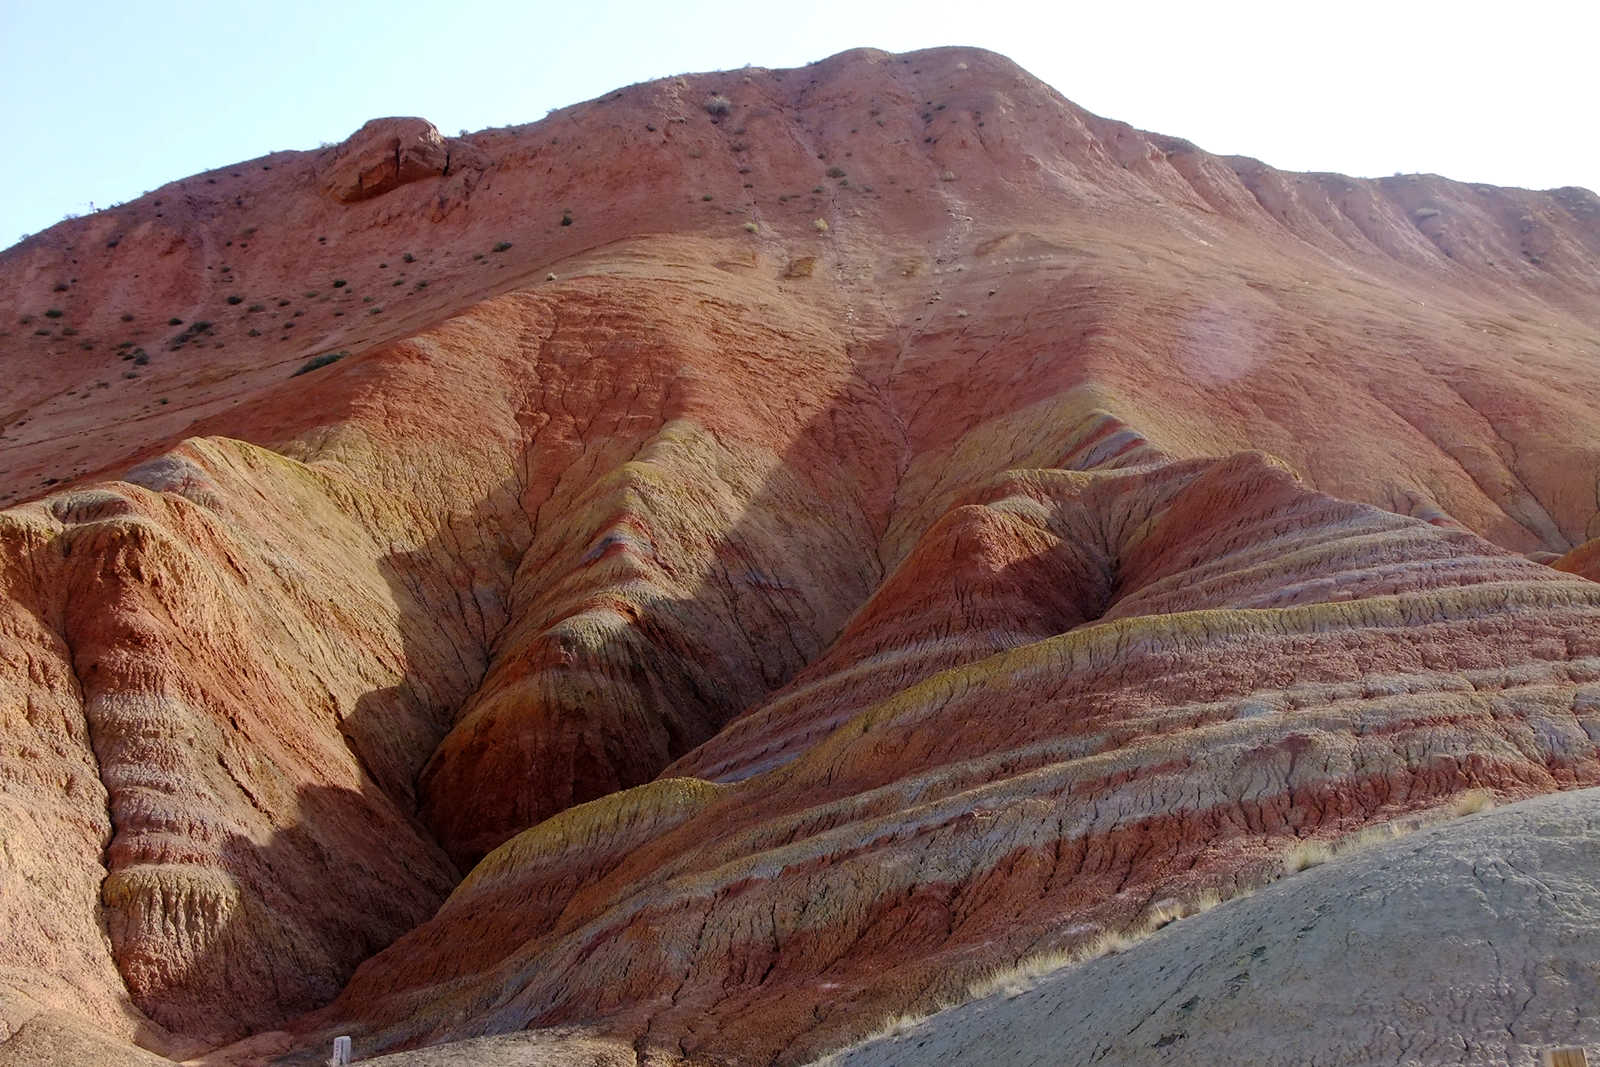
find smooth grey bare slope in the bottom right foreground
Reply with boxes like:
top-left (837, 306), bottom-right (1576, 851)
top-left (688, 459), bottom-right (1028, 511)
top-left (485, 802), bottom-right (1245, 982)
top-left (826, 789), bottom-right (1600, 1067)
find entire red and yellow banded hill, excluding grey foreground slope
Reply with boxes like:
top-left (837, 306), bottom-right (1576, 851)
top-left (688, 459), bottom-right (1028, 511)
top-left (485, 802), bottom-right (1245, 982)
top-left (0, 50), bottom-right (1600, 1064)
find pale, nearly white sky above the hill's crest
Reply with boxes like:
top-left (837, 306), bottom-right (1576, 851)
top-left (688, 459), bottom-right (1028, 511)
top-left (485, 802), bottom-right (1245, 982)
top-left (0, 0), bottom-right (1600, 246)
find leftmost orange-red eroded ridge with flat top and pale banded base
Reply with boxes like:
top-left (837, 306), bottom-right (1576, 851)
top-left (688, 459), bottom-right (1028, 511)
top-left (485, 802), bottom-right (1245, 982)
top-left (8, 440), bottom-right (505, 1043)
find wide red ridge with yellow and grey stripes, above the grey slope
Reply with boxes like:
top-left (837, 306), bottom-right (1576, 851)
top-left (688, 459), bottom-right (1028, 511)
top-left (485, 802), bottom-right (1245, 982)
top-left (304, 454), bottom-right (1600, 1062)
